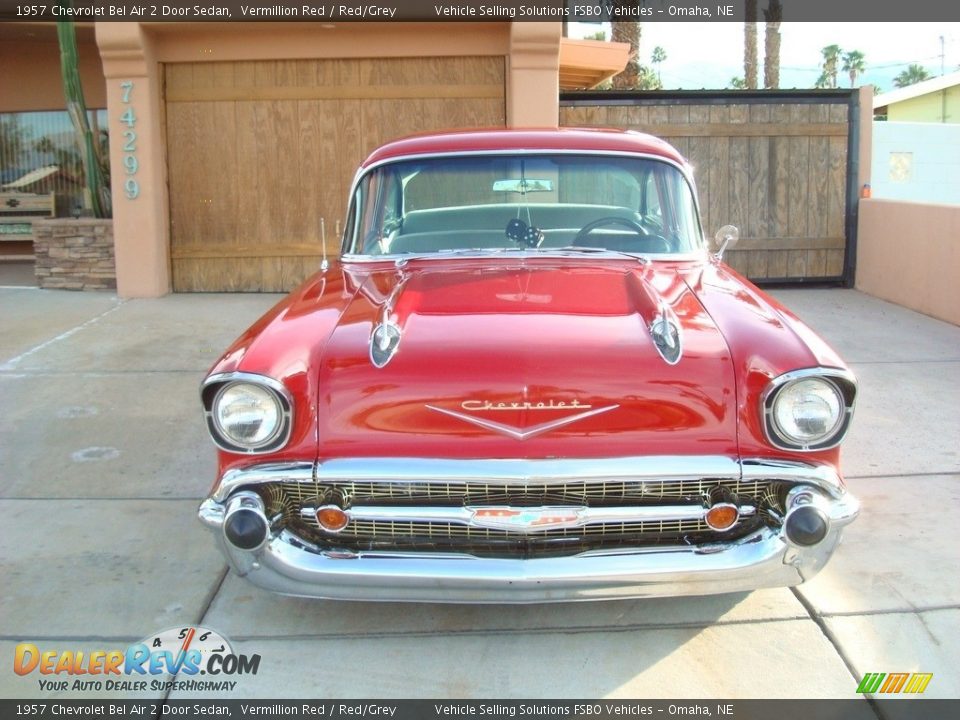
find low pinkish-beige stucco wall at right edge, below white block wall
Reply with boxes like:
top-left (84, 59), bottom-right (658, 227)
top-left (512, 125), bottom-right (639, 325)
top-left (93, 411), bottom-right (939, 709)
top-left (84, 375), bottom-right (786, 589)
top-left (856, 198), bottom-right (960, 325)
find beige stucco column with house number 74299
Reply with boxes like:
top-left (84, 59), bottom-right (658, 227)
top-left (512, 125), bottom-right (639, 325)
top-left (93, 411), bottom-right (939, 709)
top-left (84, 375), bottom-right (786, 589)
top-left (96, 22), bottom-right (170, 298)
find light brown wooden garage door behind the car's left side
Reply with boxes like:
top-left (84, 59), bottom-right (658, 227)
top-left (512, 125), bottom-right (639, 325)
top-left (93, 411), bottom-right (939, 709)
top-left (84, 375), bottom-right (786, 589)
top-left (165, 57), bottom-right (505, 292)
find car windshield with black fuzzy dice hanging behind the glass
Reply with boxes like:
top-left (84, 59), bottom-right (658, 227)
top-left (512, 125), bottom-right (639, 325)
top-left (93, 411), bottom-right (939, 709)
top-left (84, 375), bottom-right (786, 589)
top-left (344, 154), bottom-right (702, 257)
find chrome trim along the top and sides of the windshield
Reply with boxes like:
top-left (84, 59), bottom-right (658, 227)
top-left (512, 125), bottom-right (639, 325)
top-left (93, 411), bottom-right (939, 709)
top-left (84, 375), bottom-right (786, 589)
top-left (340, 148), bottom-right (708, 262)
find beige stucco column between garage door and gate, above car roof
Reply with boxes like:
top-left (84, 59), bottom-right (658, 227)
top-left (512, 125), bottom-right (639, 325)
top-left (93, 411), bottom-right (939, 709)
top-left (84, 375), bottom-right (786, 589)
top-left (507, 22), bottom-right (563, 127)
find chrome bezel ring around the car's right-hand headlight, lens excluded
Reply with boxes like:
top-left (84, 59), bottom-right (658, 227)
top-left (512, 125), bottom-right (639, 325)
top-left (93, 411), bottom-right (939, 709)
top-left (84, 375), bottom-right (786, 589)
top-left (760, 368), bottom-right (857, 452)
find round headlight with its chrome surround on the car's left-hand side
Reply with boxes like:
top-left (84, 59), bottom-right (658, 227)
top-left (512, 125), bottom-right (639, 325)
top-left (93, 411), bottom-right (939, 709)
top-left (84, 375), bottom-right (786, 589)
top-left (203, 373), bottom-right (291, 452)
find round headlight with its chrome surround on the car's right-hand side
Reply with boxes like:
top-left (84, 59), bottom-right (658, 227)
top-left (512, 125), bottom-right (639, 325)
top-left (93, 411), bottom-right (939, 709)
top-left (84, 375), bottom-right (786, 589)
top-left (763, 370), bottom-right (856, 450)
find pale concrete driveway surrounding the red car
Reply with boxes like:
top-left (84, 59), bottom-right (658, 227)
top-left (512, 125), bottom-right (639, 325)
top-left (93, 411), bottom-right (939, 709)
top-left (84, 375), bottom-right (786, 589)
top-left (0, 288), bottom-right (960, 699)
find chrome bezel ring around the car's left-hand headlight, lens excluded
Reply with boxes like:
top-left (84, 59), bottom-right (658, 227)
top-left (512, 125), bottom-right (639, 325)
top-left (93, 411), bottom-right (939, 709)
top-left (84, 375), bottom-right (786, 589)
top-left (200, 372), bottom-right (293, 454)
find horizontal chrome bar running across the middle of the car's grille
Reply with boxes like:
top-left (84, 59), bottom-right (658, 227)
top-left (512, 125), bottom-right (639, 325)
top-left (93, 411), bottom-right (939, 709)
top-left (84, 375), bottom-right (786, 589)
top-left (300, 505), bottom-right (756, 532)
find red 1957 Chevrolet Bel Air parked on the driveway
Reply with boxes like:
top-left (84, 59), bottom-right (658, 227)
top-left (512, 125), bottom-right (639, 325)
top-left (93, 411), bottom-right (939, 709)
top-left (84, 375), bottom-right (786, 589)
top-left (200, 130), bottom-right (859, 603)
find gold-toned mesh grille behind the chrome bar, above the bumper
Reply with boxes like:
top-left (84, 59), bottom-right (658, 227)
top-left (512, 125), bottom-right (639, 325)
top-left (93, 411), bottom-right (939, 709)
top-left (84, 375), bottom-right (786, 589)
top-left (256, 478), bottom-right (787, 557)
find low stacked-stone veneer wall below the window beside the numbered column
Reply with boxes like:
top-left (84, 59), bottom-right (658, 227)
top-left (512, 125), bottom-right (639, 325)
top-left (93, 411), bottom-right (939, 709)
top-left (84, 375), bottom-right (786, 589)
top-left (33, 218), bottom-right (117, 290)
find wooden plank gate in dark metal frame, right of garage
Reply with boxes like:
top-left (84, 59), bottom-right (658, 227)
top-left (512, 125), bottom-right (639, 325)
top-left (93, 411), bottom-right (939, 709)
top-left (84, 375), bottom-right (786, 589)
top-left (560, 90), bottom-right (859, 283)
